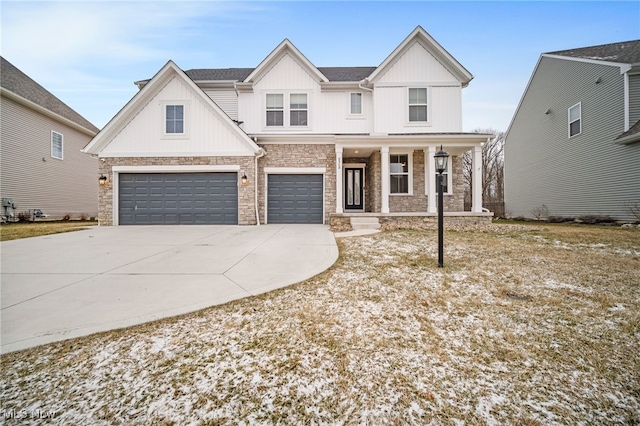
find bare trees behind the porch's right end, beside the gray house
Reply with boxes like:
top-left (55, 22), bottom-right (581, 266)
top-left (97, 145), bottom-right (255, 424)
top-left (462, 129), bottom-right (505, 213)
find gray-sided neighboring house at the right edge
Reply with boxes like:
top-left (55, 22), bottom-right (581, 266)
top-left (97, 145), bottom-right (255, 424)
top-left (505, 40), bottom-right (640, 221)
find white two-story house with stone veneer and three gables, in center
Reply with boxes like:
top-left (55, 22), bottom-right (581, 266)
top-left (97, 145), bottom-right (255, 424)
top-left (80, 27), bottom-right (492, 225)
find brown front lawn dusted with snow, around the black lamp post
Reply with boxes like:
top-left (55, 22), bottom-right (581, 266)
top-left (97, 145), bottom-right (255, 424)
top-left (0, 225), bottom-right (640, 425)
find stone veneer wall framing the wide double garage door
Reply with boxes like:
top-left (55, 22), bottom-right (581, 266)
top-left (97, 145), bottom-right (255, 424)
top-left (98, 157), bottom-right (256, 225)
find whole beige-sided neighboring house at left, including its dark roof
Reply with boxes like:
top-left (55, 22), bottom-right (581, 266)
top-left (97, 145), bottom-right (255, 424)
top-left (0, 58), bottom-right (99, 218)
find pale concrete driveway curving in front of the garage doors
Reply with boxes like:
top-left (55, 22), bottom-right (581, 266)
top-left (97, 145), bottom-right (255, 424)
top-left (0, 225), bottom-right (338, 353)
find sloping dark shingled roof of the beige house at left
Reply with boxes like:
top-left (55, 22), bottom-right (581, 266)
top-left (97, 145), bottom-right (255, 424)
top-left (0, 56), bottom-right (100, 133)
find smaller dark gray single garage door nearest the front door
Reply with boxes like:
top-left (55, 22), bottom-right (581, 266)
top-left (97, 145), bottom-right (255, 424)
top-left (267, 174), bottom-right (323, 223)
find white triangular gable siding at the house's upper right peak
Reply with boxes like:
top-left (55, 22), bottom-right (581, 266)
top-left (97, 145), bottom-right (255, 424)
top-left (377, 41), bottom-right (459, 84)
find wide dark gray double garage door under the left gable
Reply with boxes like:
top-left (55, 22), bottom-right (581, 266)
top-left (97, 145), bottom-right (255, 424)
top-left (118, 173), bottom-right (238, 225)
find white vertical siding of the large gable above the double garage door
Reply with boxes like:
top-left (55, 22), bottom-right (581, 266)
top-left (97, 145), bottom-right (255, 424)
top-left (101, 77), bottom-right (253, 157)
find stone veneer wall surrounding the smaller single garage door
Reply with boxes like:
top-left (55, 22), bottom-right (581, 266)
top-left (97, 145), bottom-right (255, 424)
top-left (251, 143), bottom-right (336, 224)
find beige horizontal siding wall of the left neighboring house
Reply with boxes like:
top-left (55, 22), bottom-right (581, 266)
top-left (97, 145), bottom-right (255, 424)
top-left (0, 97), bottom-right (98, 217)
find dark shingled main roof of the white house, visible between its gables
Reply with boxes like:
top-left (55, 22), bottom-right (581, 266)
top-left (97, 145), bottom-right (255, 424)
top-left (180, 67), bottom-right (376, 81)
